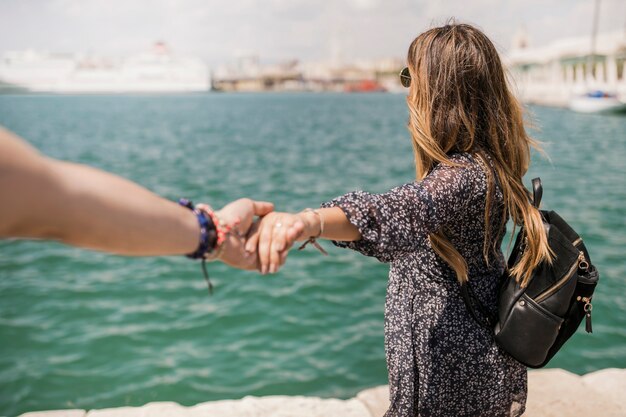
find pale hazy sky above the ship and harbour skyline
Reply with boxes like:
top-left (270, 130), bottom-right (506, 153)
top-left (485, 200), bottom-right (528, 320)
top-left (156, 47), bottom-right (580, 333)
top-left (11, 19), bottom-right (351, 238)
top-left (0, 0), bottom-right (626, 64)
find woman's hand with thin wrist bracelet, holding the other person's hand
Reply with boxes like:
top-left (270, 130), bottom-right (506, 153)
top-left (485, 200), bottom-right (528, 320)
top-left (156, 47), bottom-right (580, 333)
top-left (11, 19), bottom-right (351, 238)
top-left (246, 212), bottom-right (319, 275)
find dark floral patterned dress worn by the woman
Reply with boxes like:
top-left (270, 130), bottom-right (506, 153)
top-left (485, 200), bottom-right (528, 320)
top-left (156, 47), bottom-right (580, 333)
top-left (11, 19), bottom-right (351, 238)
top-left (322, 153), bottom-right (527, 417)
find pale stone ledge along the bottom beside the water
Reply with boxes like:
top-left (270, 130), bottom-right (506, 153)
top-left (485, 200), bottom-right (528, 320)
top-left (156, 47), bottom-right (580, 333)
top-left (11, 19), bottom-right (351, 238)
top-left (20, 368), bottom-right (626, 417)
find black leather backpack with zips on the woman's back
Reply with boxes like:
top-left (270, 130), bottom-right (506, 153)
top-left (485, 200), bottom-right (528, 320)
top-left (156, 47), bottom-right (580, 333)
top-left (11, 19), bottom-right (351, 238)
top-left (461, 178), bottom-right (599, 368)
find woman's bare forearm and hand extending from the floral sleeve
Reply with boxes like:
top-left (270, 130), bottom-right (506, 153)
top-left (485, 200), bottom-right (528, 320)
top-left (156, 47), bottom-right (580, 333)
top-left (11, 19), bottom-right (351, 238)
top-left (246, 207), bottom-right (361, 274)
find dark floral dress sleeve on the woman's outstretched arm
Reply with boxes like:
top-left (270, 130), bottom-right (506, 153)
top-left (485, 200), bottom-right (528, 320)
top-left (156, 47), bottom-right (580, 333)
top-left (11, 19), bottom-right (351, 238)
top-left (322, 158), bottom-right (476, 262)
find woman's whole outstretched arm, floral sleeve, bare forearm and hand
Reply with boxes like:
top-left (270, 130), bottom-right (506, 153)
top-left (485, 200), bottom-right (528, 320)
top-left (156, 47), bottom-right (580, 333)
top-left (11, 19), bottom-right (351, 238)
top-left (247, 154), bottom-right (476, 272)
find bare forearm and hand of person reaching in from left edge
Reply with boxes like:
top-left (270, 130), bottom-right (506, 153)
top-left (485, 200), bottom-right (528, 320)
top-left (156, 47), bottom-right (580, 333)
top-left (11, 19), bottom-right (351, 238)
top-left (0, 127), bottom-right (272, 264)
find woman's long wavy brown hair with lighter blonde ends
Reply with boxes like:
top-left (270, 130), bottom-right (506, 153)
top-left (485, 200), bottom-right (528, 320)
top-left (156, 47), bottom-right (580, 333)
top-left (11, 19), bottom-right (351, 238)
top-left (407, 23), bottom-right (552, 286)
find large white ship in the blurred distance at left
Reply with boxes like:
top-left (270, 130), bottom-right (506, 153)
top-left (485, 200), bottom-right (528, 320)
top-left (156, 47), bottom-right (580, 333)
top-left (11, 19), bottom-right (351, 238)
top-left (0, 42), bottom-right (211, 93)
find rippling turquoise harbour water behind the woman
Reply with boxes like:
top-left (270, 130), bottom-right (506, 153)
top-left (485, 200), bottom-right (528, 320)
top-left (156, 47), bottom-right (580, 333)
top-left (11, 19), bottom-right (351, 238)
top-left (0, 94), bottom-right (626, 415)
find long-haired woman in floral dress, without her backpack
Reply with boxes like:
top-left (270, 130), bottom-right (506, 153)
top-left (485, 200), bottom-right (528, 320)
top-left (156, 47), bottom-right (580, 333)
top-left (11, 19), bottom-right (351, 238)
top-left (246, 24), bottom-right (550, 416)
